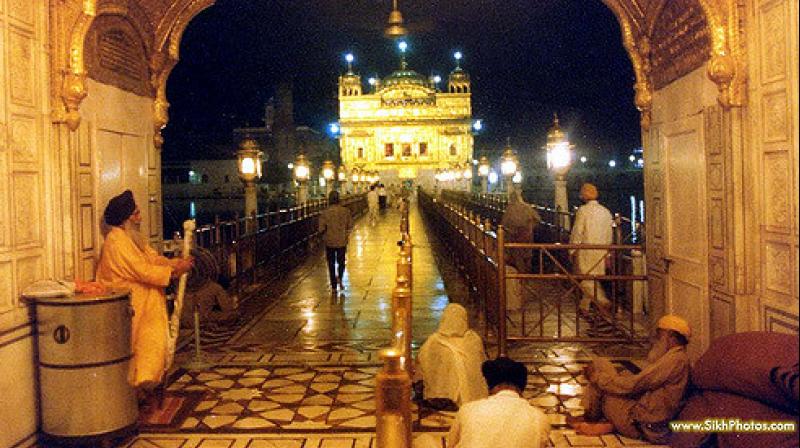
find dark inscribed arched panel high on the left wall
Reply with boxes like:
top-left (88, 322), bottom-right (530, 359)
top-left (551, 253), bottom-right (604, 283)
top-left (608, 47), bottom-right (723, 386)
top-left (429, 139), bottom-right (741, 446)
top-left (84, 16), bottom-right (153, 97)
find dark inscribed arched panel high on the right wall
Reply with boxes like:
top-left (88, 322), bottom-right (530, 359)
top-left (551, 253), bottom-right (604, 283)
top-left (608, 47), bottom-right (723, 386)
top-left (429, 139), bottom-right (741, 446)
top-left (650, 0), bottom-right (711, 89)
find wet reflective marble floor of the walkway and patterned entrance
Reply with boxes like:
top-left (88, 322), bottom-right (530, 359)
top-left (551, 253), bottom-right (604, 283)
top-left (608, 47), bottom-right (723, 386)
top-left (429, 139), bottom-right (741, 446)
top-left (126, 208), bottom-right (664, 448)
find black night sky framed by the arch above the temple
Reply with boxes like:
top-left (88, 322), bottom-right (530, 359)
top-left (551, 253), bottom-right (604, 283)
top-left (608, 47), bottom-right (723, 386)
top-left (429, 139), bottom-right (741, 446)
top-left (163, 0), bottom-right (640, 160)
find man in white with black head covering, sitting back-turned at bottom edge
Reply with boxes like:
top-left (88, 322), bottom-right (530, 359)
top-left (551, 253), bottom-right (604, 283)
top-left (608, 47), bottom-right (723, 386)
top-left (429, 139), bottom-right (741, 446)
top-left (447, 358), bottom-right (550, 448)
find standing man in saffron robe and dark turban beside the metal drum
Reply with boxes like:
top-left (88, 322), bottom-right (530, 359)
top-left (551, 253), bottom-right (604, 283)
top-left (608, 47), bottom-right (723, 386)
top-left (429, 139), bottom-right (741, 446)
top-left (96, 190), bottom-right (192, 390)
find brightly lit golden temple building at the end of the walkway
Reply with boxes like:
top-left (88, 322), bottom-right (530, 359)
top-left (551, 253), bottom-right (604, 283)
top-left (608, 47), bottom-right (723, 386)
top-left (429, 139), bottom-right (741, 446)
top-left (339, 63), bottom-right (473, 186)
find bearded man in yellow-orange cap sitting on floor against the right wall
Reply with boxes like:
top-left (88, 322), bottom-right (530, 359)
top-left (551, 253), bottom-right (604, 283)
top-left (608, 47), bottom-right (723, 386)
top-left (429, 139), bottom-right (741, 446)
top-left (570, 314), bottom-right (691, 443)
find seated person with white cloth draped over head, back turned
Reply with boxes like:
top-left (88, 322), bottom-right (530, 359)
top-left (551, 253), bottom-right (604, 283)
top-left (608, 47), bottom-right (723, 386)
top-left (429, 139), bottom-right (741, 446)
top-left (416, 303), bottom-right (487, 410)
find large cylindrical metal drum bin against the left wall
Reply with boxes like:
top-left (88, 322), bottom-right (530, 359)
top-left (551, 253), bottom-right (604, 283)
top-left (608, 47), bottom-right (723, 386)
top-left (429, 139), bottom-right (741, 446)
top-left (25, 291), bottom-right (139, 445)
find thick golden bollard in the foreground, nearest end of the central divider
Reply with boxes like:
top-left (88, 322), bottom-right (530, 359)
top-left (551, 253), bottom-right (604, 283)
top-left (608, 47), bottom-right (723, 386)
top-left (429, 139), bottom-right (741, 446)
top-left (375, 348), bottom-right (411, 448)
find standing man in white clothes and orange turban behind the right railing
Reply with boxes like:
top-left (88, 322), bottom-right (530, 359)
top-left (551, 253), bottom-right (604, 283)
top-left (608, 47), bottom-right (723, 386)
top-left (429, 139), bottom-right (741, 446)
top-left (569, 183), bottom-right (613, 313)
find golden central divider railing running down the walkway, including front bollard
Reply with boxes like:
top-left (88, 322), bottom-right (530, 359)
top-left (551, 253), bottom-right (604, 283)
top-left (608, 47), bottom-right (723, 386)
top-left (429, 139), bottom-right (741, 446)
top-left (375, 200), bottom-right (414, 448)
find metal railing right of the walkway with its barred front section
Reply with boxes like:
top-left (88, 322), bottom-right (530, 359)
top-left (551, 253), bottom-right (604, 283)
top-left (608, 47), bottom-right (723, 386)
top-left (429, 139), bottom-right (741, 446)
top-left (419, 187), bottom-right (647, 353)
